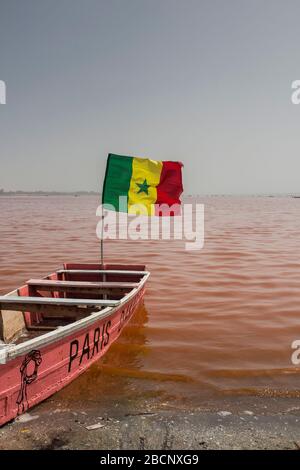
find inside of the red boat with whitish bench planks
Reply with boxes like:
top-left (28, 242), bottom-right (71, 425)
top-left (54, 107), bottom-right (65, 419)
top-left (0, 263), bottom-right (147, 344)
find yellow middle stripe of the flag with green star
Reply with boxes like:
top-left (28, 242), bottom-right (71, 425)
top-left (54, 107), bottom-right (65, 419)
top-left (128, 157), bottom-right (163, 215)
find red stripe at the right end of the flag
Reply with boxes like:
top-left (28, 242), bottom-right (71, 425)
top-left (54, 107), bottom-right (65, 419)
top-left (156, 162), bottom-right (183, 215)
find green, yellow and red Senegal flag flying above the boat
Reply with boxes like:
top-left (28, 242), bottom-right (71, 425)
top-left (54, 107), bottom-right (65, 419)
top-left (102, 153), bottom-right (183, 215)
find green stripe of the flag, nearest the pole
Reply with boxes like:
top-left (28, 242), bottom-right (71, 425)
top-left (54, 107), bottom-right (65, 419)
top-left (102, 153), bottom-right (133, 212)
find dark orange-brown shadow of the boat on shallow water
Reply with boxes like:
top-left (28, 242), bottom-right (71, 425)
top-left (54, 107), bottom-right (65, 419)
top-left (41, 303), bottom-right (199, 411)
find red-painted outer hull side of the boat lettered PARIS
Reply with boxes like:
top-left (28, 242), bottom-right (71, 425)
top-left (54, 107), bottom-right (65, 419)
top-left (0, 262), bottom-right (145, 425)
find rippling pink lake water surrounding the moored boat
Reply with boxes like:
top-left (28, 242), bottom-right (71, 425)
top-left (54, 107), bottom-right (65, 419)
top-left (0, 196), bottom-right (300, 404)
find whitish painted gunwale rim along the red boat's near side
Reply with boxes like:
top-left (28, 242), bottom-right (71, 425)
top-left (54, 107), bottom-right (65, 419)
top-left (0, 270), bottom-right (150, 365)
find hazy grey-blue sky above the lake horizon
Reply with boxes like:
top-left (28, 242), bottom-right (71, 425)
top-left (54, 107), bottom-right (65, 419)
top-left (0, 0), bottom-right (300, 194)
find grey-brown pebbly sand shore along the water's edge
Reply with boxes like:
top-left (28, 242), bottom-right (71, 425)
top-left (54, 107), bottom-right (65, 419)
top-left (0, 397), bottom-right (300, 450)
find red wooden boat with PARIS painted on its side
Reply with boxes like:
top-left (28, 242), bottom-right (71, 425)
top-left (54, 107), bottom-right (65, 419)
top-left (0, 264), bottom-right (149, 425)
